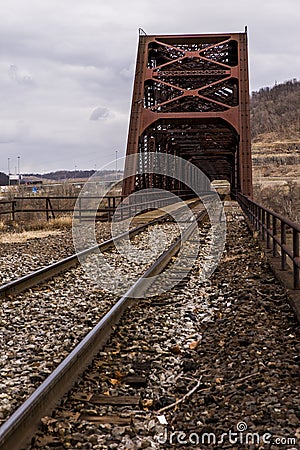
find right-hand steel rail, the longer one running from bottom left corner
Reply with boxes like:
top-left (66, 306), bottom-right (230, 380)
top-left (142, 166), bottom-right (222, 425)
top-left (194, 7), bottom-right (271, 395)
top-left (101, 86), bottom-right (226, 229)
top-left (0, 211), bottom-right (207, 450)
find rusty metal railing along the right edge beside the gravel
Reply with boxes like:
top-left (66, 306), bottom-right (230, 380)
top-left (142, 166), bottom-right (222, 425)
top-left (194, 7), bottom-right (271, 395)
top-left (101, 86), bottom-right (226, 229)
top-left (237, 194), bottom-right (300, 289)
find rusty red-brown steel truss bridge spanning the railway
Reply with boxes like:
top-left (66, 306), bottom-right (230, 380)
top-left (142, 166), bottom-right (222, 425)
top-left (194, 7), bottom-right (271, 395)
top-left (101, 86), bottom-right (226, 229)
top-left (123, 30), bottom-right (252, 197)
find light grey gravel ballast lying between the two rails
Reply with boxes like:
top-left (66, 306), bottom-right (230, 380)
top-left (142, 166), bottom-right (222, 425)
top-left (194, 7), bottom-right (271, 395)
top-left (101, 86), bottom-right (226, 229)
top-left (0, 223), bottom-right (178, 423)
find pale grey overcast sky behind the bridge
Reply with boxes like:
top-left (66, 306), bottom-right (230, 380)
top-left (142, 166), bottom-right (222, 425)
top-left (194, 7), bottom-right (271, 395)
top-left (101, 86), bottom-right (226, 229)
top-left (0, 0), bottom-right (300, 173)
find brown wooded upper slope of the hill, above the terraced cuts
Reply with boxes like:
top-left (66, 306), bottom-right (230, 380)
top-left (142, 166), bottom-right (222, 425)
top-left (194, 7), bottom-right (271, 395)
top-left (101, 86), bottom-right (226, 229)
top-left (250, 79), bottom-right (300, 142)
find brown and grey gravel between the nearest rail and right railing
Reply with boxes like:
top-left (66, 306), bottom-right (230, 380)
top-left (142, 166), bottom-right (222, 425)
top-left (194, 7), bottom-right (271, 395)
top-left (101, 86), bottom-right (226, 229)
top-left (29, 205), bottom-right (300, 450)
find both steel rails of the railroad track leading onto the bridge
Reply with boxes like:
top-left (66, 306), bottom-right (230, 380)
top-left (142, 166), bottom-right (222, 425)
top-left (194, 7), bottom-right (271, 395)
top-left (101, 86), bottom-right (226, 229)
top-left (0, 201), bottom-right (211, 450)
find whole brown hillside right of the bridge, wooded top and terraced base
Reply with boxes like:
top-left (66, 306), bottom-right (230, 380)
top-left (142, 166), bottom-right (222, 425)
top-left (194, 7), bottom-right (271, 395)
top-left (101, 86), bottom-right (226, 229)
top-left (250, 79), bottom-right (300, 222)
